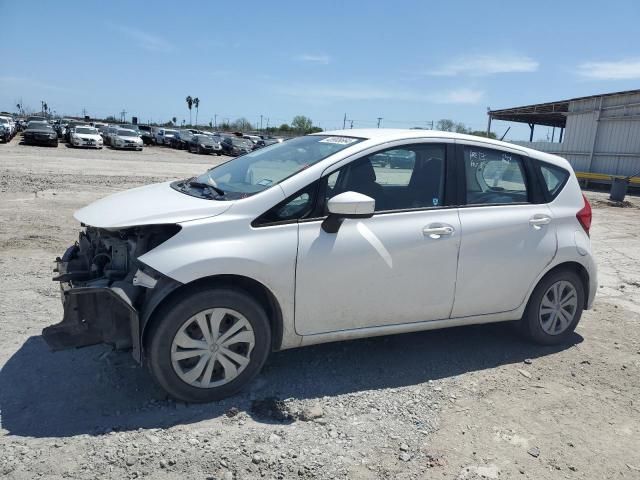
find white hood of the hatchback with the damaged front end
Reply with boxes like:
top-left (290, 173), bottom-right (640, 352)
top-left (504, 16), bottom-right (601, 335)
top-left (74, 182), bottom-right (233, 230)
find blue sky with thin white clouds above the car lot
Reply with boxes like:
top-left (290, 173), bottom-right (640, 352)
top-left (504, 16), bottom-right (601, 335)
top-left (0, 0), bottom-right (640, 139)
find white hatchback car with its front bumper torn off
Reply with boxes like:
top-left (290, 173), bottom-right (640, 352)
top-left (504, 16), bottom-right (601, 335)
top-left (43, 129), bottom-right (596, 402)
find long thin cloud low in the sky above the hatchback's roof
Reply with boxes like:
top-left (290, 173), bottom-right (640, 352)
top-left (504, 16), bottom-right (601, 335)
top-left (278, 85), bottom-right (484, 104)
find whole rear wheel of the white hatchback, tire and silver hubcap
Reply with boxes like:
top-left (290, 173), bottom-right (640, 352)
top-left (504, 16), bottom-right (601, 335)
top-left (520, 270), bottom-right (585, 345)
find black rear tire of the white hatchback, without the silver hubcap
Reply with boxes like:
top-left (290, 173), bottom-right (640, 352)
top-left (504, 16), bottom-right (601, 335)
top-left (519, 270), bottom-right (585, 345)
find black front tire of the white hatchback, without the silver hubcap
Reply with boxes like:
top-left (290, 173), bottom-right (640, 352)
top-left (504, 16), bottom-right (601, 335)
top-left (145, 288), bottom-right (271, 403)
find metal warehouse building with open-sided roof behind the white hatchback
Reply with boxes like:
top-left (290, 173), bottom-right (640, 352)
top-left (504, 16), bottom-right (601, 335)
top-left (487, 90), bottom-right (640, 184)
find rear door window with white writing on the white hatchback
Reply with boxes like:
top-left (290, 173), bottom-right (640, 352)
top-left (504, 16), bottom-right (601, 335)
top-left (464, 147), bottom-right (529, 205)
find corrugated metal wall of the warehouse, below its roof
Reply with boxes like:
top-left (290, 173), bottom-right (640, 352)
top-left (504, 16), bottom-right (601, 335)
top-left (516, 93), bottom-right (640, 175)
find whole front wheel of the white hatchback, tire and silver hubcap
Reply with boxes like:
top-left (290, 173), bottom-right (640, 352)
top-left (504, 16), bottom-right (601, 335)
top-left (146, 289), bottom-right (271, 402)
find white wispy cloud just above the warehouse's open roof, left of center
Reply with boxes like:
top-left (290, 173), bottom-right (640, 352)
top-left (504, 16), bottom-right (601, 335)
top-left (428, 53), bottom-right (540, 77)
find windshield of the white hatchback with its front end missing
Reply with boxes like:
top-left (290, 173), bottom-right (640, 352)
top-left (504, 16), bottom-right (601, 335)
top-left (173, 135), bottom-right (362, 200)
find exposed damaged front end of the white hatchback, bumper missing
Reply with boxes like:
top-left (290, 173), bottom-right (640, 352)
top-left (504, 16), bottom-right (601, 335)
top-left (42, 225), bottom-right (180, 362)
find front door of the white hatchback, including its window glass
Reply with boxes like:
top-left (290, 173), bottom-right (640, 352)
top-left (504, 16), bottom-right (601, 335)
top-left (295, 143), bottom-right (460, 335)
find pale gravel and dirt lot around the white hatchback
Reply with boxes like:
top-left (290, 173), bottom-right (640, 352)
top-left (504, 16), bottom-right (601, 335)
top-left (0, 138), bottom-right (640, 480)
